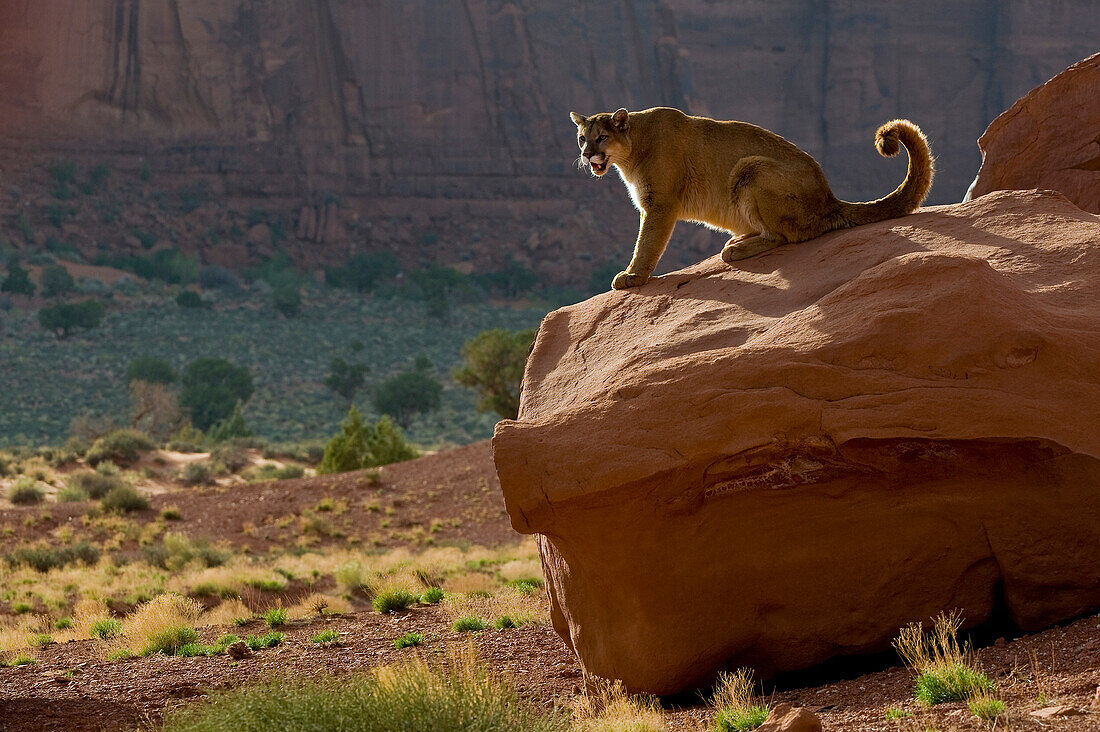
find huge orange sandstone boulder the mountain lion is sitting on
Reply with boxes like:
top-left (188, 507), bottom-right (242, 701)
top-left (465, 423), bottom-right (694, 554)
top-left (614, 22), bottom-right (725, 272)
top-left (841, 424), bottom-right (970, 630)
top-left (493, 190), bottom-right (1100, 693)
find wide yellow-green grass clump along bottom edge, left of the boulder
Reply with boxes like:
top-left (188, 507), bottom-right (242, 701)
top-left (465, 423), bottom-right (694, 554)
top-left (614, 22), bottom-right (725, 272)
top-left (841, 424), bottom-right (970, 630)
top-left (163, 660), bottom-right (569, 732)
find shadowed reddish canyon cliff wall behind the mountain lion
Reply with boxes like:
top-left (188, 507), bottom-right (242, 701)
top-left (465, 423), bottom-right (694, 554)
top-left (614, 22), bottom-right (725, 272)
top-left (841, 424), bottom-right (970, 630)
top-left (0, 0), bottom-right (1100, 281)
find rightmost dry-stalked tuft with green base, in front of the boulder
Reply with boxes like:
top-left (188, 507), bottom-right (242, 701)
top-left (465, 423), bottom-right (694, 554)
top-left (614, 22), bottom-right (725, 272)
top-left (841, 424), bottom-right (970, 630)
top-left (893, 613), bottom-right (994, 704)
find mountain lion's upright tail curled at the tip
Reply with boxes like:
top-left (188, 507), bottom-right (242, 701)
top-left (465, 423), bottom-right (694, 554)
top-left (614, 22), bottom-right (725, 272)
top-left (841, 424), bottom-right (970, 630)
top-left (840, 120), bottom-right (935, 226)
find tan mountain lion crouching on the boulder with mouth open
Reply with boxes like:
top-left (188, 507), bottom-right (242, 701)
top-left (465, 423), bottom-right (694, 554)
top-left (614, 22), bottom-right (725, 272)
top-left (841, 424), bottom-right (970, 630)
top-left (570, 107), bottom-right (933, 289)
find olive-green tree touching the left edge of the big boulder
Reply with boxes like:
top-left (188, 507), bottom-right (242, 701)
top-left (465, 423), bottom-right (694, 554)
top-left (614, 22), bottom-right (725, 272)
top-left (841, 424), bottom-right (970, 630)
top-left (454, 329), bottom-right (535, 419)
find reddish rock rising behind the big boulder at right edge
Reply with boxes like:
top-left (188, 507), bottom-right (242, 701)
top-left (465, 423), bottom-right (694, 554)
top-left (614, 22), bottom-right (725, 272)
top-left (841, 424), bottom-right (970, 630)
top-left (966, 54), bottom-right (1100, 214)
